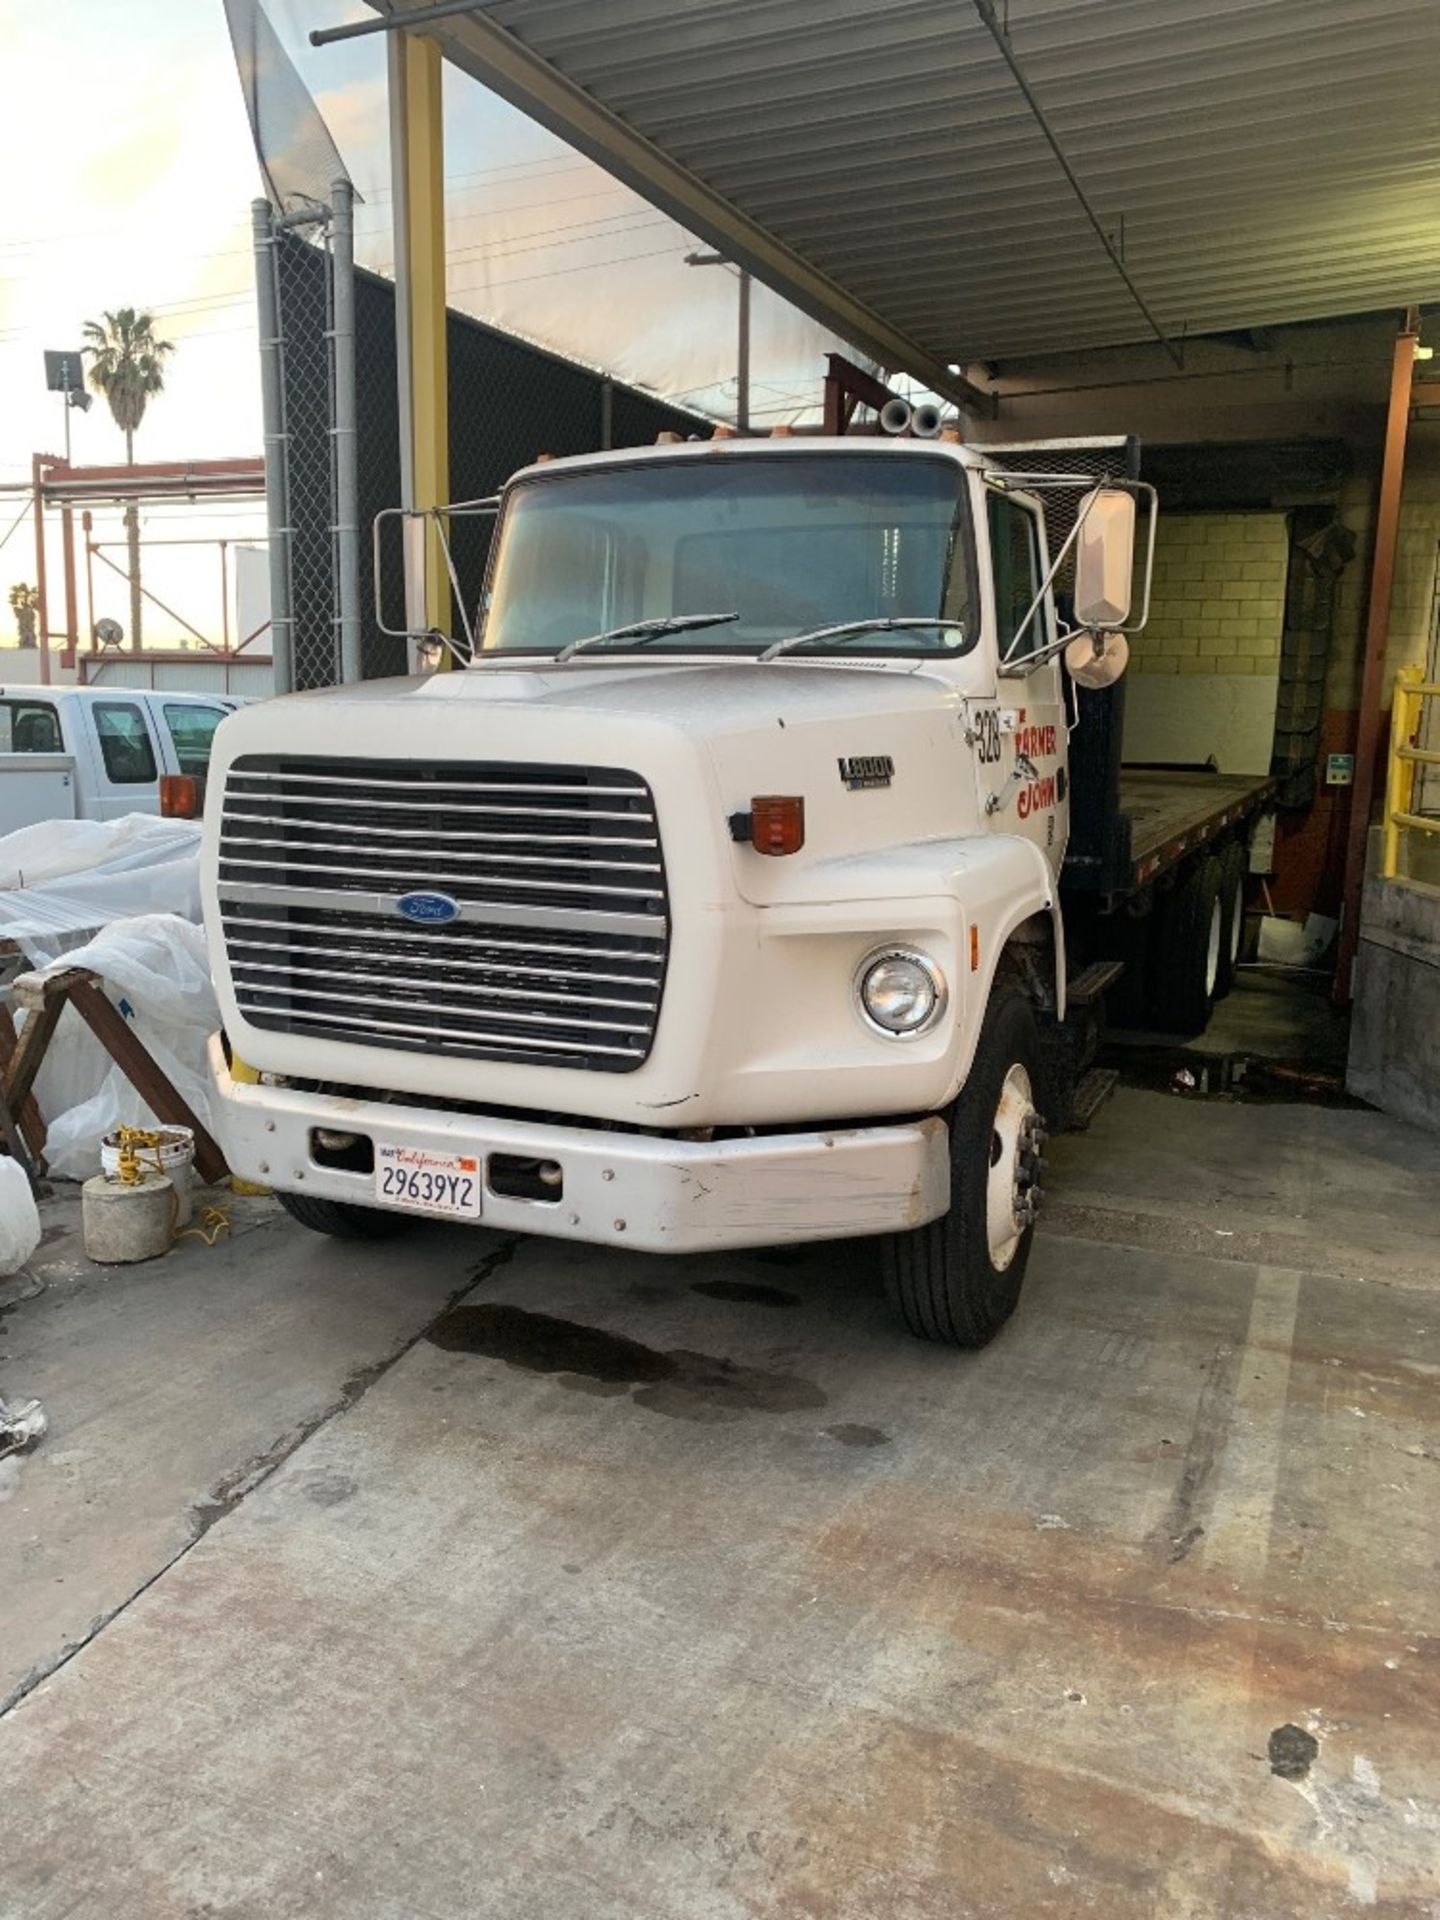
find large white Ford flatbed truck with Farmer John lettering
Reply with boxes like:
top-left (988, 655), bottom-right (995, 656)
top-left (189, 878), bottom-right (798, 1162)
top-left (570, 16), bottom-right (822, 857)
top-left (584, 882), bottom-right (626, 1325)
top-left (204, 438), bottom-right (1263, 1346)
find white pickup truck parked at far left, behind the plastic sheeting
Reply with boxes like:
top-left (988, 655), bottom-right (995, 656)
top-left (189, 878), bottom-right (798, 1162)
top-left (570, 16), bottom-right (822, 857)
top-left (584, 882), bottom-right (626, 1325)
top-left (0, 685), bottom-right (236, 833)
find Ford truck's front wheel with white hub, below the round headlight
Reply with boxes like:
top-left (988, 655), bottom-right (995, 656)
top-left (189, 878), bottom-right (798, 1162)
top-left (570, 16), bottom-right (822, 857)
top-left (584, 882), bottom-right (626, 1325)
top-left (883, 987), bottom-right (1044, 1348)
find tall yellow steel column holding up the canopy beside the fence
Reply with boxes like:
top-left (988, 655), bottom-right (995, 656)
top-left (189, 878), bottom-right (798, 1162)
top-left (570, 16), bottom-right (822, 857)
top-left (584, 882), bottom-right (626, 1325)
top-left (390, 33), bottom-right (451, 652)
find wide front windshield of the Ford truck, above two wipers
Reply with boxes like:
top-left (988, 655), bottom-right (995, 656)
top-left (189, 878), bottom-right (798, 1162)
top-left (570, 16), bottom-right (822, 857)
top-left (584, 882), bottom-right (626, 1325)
top-left (478, 453), bottom-right (975, 657)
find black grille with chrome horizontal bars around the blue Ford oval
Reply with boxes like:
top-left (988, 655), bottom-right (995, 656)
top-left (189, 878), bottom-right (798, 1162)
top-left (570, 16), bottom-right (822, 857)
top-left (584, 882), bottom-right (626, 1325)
top-left (219, 755), bottom-right (668, 1073)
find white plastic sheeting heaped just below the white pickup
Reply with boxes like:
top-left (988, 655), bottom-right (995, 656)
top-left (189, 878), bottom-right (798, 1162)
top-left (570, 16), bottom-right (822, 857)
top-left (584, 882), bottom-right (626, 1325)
top-left (0, 814), bottom-right (200, 966)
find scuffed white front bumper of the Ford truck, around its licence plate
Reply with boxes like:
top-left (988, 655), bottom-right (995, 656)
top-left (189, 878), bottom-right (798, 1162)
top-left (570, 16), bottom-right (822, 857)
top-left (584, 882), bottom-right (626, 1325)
top-left (209, 1033), bottom-right (950, 1254)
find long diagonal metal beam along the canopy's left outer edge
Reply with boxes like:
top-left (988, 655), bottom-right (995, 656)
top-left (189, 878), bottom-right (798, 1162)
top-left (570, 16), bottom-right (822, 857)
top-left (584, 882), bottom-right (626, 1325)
top-left (355, 0), bottom-right (993, 419)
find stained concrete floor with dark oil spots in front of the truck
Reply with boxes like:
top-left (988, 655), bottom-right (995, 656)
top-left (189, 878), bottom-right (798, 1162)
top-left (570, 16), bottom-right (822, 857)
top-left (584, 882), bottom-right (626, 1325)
top-left (0, 983), bottom-right (1440, 1920)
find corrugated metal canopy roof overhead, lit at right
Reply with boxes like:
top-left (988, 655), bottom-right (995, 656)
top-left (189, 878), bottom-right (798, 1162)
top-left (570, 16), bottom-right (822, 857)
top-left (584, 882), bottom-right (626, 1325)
top-left (376, 0), bottom-right (1440, 401)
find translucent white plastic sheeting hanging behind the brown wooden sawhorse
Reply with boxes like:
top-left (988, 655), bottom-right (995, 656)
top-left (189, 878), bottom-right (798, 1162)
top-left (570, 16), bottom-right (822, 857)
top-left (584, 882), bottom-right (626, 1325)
top-left (35, 914), bottom-right (221, 1181)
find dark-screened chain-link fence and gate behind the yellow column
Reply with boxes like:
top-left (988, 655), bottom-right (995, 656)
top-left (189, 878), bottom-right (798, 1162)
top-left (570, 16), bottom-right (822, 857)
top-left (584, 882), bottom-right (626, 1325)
top-left (261, 228), bottom-right (710, 687)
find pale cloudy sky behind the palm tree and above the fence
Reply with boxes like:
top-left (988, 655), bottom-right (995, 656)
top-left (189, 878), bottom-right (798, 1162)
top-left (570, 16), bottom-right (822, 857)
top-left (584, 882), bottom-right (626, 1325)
top-left (0, 0), bottom-right (837, 643)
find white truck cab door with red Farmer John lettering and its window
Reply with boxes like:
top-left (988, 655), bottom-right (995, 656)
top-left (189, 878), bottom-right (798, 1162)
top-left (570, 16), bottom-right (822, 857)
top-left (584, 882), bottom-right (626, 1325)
top-left (973, 486), bottom-right (1069, 874)
